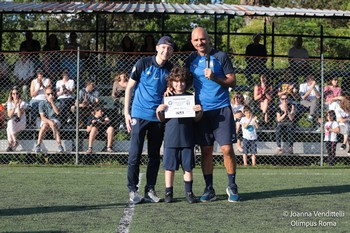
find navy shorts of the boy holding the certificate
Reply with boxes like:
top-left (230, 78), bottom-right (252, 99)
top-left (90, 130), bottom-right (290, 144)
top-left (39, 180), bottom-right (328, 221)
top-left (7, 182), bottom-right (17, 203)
top-left (163, 147), bottom-right (195, 171)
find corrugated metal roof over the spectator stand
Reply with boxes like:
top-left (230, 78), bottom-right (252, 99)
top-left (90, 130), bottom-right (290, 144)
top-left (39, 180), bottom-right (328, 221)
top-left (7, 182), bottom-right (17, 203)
top-left (0, 2), bottom-right (350, 18)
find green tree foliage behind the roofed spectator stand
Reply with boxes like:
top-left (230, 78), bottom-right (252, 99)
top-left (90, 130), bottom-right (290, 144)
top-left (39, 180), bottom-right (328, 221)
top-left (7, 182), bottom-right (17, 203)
top-left (2, 0), bottom-right (350, 57)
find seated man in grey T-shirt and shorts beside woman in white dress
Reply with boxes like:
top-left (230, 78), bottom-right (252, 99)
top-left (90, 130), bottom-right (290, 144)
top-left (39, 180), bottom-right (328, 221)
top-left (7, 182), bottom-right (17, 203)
top-left (35, 87), bottom-right (64, 153)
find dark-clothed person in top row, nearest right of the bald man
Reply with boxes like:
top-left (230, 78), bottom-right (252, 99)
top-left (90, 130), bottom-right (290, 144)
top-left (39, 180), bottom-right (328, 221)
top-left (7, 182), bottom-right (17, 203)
top-left (245, 33), bottom-right (267, 87)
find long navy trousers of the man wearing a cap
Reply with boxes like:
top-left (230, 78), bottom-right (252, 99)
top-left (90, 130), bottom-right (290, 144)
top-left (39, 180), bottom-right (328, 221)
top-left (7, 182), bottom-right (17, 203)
top-left (128, 118), bottom-right (164, 192)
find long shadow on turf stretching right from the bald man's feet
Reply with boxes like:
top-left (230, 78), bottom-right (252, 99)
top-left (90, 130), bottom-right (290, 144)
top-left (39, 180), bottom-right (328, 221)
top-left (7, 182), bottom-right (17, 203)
top-left (217, 185), bottom-right (350, 201)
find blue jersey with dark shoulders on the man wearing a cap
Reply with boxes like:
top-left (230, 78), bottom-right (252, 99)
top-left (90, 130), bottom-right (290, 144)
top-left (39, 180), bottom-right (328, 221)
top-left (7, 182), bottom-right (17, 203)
top-left (130, 56), bottom-right (173, 121)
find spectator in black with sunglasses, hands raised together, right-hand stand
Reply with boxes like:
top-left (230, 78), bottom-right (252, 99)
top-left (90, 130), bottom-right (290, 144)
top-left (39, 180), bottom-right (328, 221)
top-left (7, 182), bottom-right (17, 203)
top-left (276, 94), bottom-right (295, 155)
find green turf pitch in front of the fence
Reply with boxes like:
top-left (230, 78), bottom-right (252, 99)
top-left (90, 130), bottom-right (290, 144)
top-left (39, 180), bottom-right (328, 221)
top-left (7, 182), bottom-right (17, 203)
top-left (0, 166), bottom-right (350, 233)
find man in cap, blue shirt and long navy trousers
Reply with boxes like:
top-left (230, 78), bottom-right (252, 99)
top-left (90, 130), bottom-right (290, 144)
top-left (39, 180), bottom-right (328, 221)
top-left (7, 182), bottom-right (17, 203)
top-left (124, 36), bottom-right (175, 204)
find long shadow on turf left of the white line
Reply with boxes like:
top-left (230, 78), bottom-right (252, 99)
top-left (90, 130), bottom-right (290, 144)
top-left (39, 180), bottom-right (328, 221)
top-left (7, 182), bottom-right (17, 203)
top-left (0, 203), bottom-right (125, 216)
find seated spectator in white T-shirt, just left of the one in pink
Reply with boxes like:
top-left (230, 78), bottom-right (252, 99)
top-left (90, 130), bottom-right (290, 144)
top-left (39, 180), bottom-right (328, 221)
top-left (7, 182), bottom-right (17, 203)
top-left (299, 74), bottom-right (321, 127)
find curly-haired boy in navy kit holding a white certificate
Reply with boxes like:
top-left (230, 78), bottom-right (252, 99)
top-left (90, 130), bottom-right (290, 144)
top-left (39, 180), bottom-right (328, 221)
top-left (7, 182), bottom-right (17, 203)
top-left (156, 67), bottom-right (203, 203)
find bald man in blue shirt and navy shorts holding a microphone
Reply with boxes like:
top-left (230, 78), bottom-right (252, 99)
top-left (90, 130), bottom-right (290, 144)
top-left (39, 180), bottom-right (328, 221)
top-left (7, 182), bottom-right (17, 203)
top-left (185, 27), bottom-right (240, 202)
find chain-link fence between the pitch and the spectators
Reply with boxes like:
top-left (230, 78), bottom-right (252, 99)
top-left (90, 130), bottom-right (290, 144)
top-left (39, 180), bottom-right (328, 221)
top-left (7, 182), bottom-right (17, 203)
top-left (0, 51), bottom-right (350, 165)
